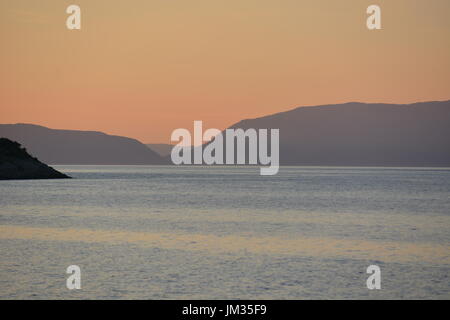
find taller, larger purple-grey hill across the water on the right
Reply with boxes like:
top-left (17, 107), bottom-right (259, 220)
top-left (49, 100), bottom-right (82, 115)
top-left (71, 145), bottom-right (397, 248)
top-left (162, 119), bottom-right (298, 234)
top-left (225, 101), bottom-right (450, 167)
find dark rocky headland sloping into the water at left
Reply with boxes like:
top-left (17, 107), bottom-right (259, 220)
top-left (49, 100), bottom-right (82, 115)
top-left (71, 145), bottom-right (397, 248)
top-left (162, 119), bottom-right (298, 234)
top-left (0, 138), bottom-right (70, 180)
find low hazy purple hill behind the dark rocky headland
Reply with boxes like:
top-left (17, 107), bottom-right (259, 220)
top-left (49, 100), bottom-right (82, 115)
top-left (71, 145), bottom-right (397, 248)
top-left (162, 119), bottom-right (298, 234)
top-left (0, 124), bottom-right (165, 165)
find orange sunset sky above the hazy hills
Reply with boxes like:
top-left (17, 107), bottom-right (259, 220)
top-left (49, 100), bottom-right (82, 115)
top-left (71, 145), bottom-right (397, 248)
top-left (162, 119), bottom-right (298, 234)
top-left (0, 0), bottom-right (450, 143)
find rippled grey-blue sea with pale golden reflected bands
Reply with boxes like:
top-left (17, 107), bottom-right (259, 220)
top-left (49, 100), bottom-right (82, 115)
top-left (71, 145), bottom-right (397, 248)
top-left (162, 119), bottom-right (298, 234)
top-left (0, 166), bottom-right (450, 299)
